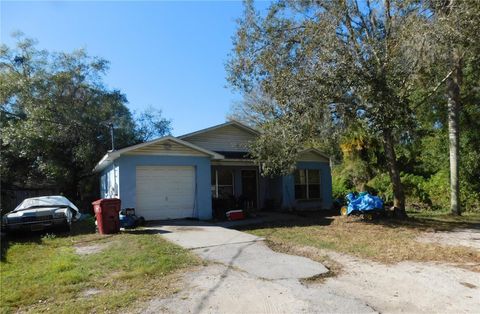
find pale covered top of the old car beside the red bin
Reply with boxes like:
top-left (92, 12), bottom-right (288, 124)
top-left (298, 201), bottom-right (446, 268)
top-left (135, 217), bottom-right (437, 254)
top-left (7, 196), bottom-right (80, 219)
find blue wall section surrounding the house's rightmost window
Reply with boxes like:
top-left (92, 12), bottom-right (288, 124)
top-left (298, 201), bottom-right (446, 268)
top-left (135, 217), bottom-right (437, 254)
top-left (282, 161), bottom-right (332, 209)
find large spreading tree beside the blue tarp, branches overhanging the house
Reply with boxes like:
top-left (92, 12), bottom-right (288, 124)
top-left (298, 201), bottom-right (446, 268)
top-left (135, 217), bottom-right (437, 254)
top-left (227, 0), bottom-right (428, 216)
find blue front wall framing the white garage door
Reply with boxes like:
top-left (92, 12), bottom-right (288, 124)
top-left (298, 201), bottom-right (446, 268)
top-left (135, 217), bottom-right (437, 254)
top-left (118, 155), bottom-right (212, 220)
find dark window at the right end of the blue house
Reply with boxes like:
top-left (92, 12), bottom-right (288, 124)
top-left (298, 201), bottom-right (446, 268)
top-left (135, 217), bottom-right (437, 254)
top-left (295, 169), bottom-right (320, 200)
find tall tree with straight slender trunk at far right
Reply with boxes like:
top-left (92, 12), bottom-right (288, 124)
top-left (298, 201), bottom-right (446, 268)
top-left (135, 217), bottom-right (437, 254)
top-left (431, 0), bottom-right (480, 215)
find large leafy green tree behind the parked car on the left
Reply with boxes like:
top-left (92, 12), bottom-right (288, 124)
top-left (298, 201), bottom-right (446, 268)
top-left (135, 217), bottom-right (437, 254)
top-left (0, 34), bottom-right (170, 206)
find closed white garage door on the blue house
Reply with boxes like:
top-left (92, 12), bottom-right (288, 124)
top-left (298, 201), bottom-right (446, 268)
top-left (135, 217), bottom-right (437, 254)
top-left (135, 166), bottom-right (195, 220)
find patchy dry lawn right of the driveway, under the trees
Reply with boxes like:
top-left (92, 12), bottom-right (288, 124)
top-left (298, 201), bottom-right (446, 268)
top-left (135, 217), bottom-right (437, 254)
top-left (245, 213), bottom-right (480, 271)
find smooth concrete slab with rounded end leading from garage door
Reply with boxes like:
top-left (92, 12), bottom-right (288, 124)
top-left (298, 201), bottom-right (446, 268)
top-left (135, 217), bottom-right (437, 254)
top-left (154, 221), bottom-right (328, 279)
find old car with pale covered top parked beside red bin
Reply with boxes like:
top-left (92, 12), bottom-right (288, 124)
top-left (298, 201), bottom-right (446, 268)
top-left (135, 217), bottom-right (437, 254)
top-left (2, 196), bottom-right (81, 231)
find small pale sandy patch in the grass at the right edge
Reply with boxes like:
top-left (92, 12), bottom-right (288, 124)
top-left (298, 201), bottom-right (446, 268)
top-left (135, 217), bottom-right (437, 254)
top-left (417, 229), bottom-right (480, 251)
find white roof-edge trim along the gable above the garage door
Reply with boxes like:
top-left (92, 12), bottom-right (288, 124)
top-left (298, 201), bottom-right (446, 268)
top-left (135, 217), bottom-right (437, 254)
top-left (93, 135), bottom-right (225, 172)
